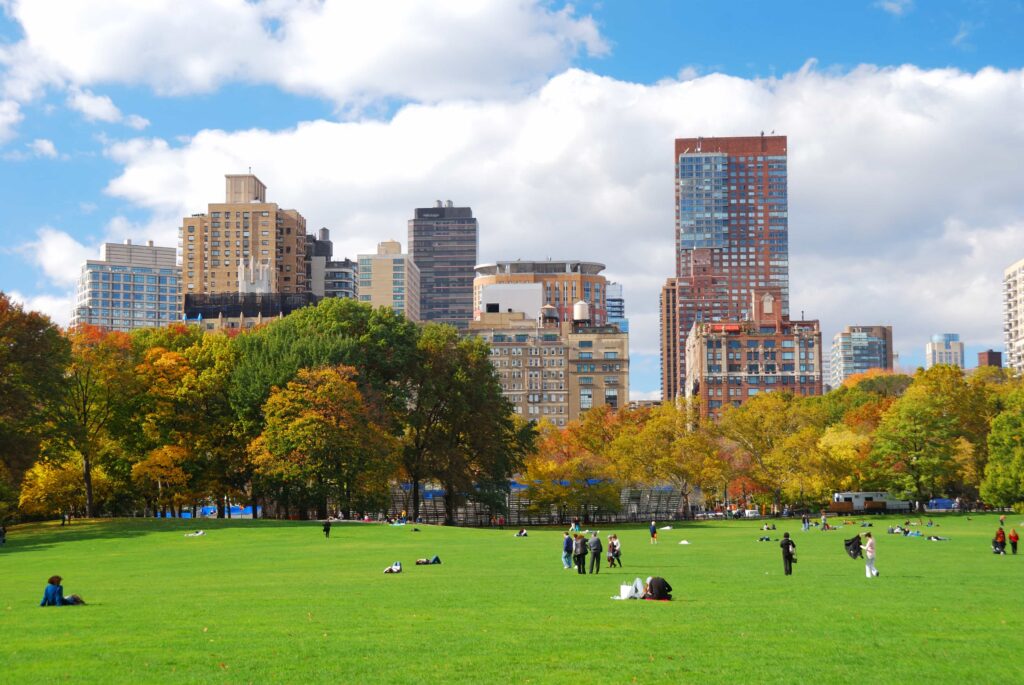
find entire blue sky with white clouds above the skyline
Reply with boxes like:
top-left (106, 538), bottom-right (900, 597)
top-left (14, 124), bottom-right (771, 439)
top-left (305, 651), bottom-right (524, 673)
top-left (0, 0), bottom-right (1024, 396)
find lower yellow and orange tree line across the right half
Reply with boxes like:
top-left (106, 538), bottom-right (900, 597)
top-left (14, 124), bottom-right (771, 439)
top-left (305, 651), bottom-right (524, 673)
top-left (524, 366), bottom-right (1024, 518)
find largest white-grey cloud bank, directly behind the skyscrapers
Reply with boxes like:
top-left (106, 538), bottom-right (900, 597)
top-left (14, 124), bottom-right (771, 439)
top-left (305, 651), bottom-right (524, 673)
top-left (101, 66), bottom-right (1024, 384)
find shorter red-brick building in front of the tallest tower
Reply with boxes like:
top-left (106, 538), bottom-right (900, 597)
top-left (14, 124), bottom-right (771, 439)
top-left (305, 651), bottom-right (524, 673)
top-left (684, 289), bottom-right (822, 419)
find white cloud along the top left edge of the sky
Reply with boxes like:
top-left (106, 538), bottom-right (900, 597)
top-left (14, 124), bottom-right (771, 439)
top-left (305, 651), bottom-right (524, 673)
top-left (0, 0), bottom-right (607, 110)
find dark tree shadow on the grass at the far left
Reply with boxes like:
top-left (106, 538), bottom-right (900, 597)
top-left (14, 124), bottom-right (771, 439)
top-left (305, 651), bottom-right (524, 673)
top-left (0, 518), bottom-right (322, 555)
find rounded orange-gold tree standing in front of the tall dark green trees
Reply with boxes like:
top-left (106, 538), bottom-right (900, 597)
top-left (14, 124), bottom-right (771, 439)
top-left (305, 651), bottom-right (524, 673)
top-left (250, 367), bottom-right (397, 517)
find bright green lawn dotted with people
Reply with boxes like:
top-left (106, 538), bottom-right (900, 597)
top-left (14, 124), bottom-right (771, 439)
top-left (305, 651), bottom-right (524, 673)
top-left (0, 515), bottom-right (1024, 684)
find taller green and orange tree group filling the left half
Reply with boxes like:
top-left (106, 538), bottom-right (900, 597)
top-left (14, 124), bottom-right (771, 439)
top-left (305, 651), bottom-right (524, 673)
top-left (0, 293), bottom-right (536, 520)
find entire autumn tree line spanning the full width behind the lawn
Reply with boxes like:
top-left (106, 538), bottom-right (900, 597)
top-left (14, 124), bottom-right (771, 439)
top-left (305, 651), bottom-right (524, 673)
top-left (0, 286), bottom-right (1024, 521)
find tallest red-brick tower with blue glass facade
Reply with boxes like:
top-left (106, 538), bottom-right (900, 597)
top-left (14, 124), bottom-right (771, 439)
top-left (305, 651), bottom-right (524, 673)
top-left (662, 134), bottom-right (790, 399)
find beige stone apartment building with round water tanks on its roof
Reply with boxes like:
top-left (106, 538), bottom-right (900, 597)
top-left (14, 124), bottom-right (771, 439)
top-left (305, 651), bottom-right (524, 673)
top-left (469, 303), bottom-right (630, 426)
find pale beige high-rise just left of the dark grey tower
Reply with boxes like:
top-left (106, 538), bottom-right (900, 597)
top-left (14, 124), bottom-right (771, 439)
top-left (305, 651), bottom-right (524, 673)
top-left (358, 241), bottom-right (421, 322)
